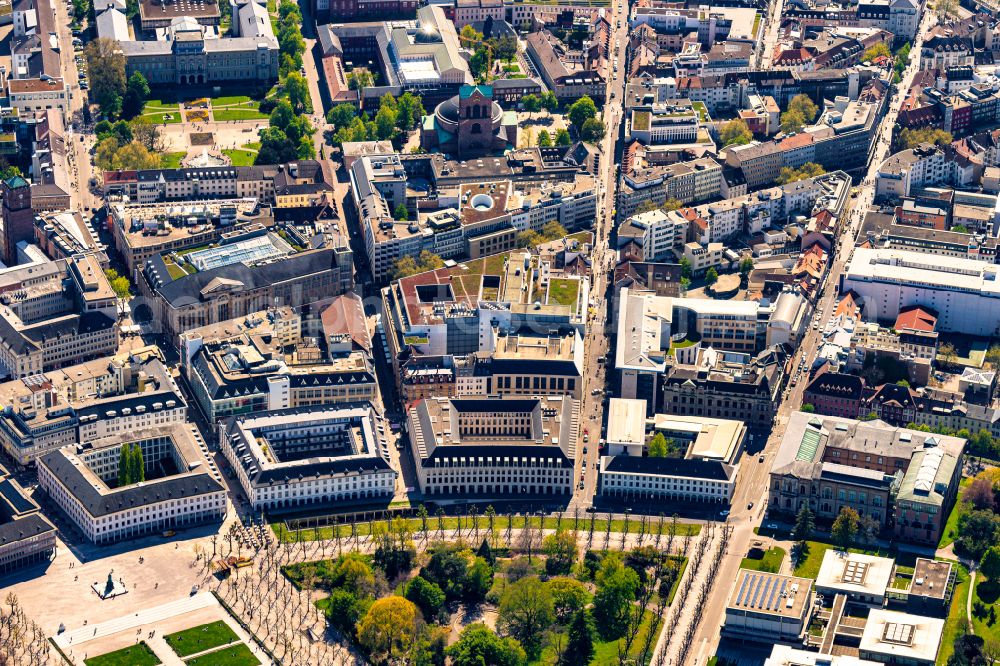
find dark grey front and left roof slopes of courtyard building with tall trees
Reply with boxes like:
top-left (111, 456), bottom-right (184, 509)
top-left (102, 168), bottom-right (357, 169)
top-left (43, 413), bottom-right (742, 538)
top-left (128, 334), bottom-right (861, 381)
top-left (39, 451), bottom-right (223, 516)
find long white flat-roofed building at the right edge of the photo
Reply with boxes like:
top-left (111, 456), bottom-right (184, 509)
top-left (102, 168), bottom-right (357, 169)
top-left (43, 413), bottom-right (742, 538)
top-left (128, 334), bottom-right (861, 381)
top-left (841, 248), bottom-right (1000, 337)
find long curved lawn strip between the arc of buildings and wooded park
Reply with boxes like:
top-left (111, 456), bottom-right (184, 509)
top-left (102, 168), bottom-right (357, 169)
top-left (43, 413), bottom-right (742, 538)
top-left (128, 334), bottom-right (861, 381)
top-left (271, 515), bottom-right (701, 543)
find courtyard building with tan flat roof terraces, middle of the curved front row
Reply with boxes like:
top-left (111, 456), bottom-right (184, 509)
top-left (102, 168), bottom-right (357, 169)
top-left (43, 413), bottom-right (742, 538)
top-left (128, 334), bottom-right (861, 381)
top-left (406, 396), bottom-right (578, 497)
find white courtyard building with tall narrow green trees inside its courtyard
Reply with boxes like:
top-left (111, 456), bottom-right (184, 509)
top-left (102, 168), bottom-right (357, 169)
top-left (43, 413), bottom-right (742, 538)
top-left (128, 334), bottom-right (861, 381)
top-left (38, 425), bottom-right (227, 544)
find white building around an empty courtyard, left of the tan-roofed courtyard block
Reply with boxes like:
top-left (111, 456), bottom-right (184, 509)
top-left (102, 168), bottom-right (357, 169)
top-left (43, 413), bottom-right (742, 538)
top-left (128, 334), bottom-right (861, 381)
top-left (219, 403), bottom-right (396, 510)
